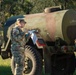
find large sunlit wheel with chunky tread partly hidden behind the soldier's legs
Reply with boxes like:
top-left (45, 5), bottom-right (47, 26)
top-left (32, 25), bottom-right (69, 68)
top-left (11, 45), bottom-right (43, 75)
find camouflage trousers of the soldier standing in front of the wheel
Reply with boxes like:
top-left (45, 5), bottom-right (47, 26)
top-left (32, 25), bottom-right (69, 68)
top-left (11, 46), bottom-right (25, 75)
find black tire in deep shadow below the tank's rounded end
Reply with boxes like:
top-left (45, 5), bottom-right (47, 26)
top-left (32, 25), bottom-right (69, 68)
top-left (51, 53), bottom-right (75, 75)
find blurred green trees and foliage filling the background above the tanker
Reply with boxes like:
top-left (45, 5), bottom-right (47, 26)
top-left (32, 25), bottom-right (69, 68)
top-left (0, 0), bottom-right (76, 24)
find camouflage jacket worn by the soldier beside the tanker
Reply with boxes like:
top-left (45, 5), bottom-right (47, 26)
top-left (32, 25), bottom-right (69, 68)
top-left (11, 26), bottom-right (26, 46)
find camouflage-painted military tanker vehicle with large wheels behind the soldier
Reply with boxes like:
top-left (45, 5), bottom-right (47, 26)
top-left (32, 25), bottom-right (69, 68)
top-left (0, 7), bottom-right (76, 75)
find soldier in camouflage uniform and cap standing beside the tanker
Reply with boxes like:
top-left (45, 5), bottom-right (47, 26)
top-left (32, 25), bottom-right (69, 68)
top-left (11, 19), bottom-right (26, 75)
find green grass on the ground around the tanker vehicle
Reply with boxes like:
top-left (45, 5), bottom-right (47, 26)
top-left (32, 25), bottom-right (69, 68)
top-left (0, 57), bottom-right (76, 75)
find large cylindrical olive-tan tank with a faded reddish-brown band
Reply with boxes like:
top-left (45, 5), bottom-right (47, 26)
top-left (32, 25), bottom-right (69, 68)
top-left (24, 10), bottom-right (76, 44)
